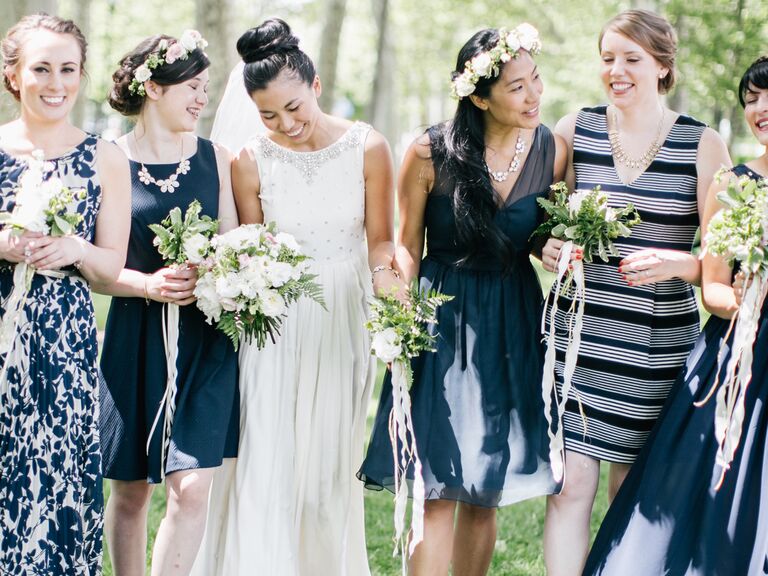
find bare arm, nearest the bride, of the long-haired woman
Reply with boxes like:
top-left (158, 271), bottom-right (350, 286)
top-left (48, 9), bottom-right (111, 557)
top-left (395, 134), bottom-right (435, 283)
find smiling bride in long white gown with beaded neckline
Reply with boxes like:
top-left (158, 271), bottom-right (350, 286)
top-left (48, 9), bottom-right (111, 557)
top-left (193, 19), bottom-right (400, 576)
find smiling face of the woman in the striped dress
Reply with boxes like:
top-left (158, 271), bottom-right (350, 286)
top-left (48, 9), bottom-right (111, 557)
top-left (600, 30), bottom-right (669, 108)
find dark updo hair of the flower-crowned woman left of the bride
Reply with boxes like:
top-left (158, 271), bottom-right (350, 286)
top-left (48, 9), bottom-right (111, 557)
top-left (107, 34), bottom-right (211, 116)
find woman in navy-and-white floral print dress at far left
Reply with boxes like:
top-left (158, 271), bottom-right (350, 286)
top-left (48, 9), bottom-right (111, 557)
top-left (0, 14), bottom-right (130, 576)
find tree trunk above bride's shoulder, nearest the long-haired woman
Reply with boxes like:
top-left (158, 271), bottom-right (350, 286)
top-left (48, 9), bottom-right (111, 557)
top-left (366, 0), bottom-right (399, 143)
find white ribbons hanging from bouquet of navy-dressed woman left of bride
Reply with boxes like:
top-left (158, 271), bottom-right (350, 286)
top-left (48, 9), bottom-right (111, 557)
top-left (147, 302), bottom-right (179, 478)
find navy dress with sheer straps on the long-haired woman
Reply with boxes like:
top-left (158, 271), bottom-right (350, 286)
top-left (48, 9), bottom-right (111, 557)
top-left (358, 126), bottom-right (557, 507)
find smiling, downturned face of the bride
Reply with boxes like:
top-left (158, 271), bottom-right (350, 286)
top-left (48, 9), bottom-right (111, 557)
top-left (251, 71), bottom-right (322, 145)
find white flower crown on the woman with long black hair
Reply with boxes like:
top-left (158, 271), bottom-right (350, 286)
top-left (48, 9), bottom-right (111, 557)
top-left (451, 22), bottom-right (541, 100)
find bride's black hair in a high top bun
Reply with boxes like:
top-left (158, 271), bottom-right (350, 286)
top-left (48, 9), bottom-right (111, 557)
top-left (237, 18), bottom-right (316, 94)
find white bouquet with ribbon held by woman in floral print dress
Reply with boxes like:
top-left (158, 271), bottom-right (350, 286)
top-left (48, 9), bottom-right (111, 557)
top-left (0, 150), bottom-right (86, 362)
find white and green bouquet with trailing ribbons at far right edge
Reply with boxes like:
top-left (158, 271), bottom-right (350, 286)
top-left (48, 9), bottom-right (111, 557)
top-left (698, 171), bottom-right (768, 487)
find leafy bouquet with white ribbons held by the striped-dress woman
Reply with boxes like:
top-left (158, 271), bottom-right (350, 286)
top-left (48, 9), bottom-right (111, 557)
top-left (533, 182), bottom-right (640, 482)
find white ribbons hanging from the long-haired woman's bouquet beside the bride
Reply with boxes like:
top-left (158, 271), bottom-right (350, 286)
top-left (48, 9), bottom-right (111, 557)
top-left (389, 360), bottom-right (425, 574)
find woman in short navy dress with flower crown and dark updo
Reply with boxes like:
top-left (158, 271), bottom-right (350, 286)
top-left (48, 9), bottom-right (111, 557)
top-left (101, 30), bottom-right (238, 576)
